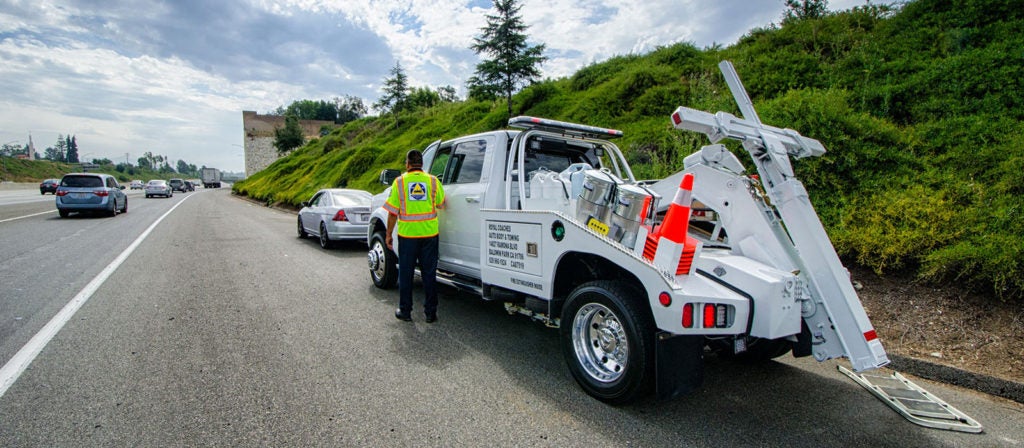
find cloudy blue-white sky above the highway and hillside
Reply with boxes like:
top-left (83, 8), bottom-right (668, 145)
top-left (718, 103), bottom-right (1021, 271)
top-left (0, 0), bottom-right (865, 172)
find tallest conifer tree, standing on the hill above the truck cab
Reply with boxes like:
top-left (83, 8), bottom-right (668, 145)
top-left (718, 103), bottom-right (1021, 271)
top-left (467, 0), bottom-right (548, 117)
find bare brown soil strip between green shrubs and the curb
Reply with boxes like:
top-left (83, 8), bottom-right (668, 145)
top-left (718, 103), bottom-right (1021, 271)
top-left (849, 267), bottom-right (1024, 383)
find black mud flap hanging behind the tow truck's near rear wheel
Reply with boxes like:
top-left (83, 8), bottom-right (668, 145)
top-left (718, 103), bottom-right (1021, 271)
top-left (654, 332), bottom-right (705, 401)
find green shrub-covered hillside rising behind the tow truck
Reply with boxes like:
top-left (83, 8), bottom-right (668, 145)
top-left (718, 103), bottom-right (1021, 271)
top-left (234, 0), bottom-right (1024, 301)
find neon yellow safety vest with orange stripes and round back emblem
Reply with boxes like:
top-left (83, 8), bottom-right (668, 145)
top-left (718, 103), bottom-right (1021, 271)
top-left (384, 170), bottom-right (444, 238)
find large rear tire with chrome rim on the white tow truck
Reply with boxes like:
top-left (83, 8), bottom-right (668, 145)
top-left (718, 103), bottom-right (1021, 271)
top-left (560, 280), bottom-right (655, 405)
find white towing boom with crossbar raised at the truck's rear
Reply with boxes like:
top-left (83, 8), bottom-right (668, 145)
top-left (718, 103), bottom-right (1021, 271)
top-left (672, 61), bottom-right (889, 371)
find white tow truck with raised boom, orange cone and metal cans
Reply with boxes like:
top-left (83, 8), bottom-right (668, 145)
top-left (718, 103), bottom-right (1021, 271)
top-left (368, 62), bottom-right (889, 404)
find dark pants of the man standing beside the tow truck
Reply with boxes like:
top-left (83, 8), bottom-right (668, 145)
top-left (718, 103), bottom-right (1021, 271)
top-left (398, 236), bottom-right (437, 316)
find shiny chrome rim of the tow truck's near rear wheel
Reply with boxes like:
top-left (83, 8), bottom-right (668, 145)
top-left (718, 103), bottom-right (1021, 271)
top-left (572, 304), bottom-right (629, 383)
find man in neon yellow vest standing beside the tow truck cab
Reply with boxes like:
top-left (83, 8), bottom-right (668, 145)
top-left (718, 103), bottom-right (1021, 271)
top-left (384, 149), bottom-right (444, 323)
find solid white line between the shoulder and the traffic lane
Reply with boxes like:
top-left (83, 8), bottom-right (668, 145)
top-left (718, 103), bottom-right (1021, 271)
top-left (0, 196), bottom-right (190, 397)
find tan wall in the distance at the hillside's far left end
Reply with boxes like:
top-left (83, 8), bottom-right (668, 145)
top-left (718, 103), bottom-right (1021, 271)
top-left (242, 110), bottom-right (334, 177)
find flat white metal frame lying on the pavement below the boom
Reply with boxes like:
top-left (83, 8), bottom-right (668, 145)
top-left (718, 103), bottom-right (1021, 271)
top-left (837, 365), bottom-right (984, 434)
